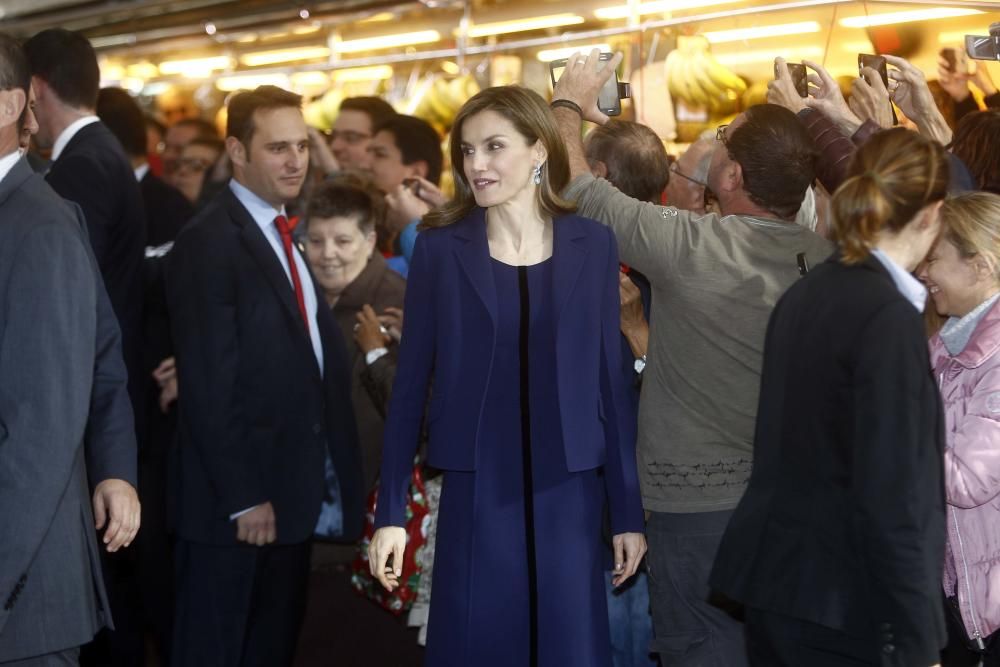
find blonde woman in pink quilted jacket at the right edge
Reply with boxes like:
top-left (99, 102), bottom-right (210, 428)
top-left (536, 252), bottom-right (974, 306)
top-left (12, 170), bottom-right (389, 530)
top-left (919, 192), bottom-right (1000, 667)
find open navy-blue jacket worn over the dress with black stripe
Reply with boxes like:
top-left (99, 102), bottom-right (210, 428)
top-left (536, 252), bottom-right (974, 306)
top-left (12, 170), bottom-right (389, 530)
top-left (376, 208), bottom-right (643, 534)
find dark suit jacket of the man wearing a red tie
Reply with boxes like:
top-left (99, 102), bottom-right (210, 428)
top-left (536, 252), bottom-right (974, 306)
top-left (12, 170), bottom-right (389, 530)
top-left (167, 187), bottom-right (363, 545)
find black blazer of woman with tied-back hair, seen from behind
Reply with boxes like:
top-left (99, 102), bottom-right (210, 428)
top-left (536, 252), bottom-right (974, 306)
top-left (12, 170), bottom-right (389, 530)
top-left (711, 256), bottom-right (945, 667)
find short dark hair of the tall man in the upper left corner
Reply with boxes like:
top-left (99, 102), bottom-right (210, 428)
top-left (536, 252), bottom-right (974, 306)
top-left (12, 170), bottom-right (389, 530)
top-left (24, 28), bottom-right (101, 109)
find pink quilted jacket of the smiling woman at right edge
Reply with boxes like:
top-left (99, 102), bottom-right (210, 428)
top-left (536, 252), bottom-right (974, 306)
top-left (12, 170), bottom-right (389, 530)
top-left (930, 301), bottom-right (1000, 639)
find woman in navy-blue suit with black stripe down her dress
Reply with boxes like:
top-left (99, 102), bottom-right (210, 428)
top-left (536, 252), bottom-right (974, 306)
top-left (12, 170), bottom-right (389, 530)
top-left (369, 86), bottom-right (646, 667)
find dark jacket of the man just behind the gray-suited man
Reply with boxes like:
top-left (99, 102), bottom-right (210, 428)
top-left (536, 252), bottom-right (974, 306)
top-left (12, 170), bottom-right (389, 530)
top-left (45, 122), bottom-right (146, 458)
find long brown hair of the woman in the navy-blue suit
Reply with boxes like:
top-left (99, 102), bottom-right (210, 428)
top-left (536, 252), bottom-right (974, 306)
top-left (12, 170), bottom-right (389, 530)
top-left (420, 86), bottom-right (575, 229)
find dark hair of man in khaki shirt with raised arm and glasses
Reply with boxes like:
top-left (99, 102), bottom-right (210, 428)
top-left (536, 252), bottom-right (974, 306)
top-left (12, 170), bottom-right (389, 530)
top-left (724, 104), bottom-right (817, 220)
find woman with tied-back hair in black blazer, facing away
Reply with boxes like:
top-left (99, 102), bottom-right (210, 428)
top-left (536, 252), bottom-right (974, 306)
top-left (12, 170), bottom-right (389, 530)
top-left (712, 129), bottom-right (948, 667)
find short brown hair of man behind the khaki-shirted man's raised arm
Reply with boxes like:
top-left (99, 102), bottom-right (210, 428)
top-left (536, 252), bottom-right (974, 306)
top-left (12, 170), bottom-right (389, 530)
top-left (585, 120), bottom-right (670, 204)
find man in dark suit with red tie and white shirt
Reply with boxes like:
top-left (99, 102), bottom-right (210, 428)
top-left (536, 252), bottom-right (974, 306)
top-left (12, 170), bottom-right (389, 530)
top-left (167, 86), bottom-right (363, 666)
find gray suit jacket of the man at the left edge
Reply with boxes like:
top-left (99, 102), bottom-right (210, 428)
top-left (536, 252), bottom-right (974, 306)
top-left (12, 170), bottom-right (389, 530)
top-left (0, 159), bottom-right (110, 662)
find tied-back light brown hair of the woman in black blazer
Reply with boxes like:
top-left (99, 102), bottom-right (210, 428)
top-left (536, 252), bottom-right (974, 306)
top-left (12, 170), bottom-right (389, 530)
top-left (831, 127), bottom-right (949, 264)
